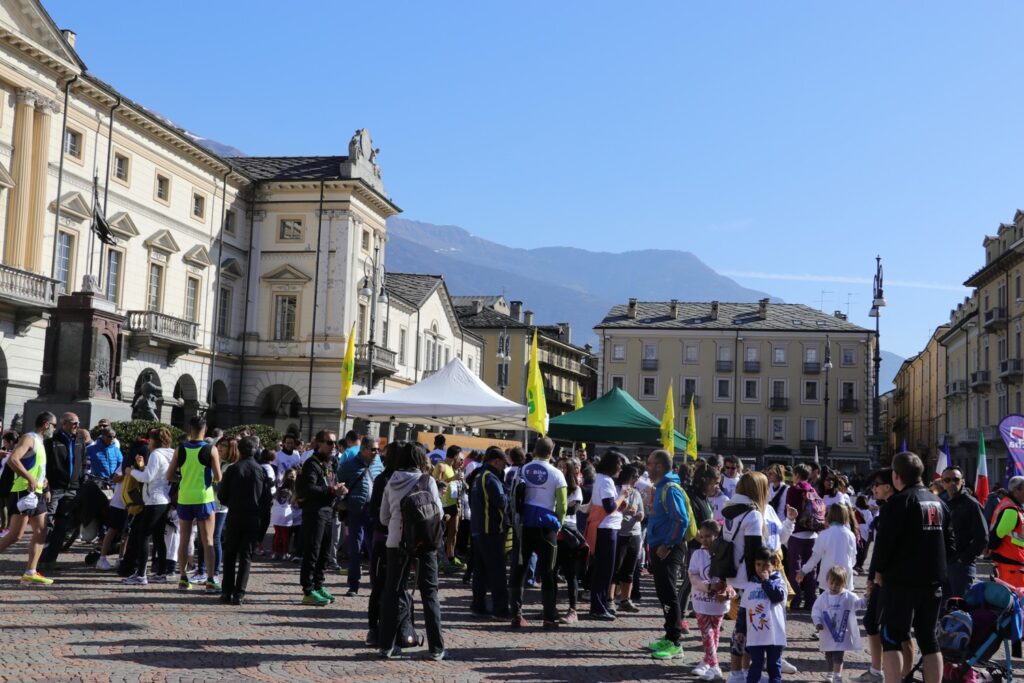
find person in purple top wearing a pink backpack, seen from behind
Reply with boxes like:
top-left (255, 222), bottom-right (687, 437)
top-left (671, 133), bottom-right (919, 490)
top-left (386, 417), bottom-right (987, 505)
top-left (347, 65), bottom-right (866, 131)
top-left (785, 464), bottom-right (827, 611)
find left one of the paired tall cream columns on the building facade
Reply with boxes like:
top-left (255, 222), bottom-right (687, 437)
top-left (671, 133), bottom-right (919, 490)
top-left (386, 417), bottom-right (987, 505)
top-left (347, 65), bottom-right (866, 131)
top-left (3, 88), bottom-right (39, 268)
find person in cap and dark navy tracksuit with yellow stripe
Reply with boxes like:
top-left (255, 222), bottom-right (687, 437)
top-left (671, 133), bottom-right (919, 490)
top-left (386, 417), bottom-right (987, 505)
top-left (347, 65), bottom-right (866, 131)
top-left (469, 445), bottom-right (509, 618)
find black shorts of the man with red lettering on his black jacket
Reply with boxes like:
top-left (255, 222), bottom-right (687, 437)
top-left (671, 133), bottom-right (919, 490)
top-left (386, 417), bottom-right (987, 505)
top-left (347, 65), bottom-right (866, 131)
top-left (879, 584), bottom-right (942, 655)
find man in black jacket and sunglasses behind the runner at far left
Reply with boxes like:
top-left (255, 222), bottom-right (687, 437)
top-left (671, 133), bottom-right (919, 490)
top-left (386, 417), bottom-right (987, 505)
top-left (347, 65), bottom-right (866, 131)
top-left (39, 413), bottom-right (91, 569)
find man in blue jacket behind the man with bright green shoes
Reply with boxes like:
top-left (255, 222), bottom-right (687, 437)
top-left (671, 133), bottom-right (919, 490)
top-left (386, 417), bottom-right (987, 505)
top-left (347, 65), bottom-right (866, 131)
top-left (337, 436), bottom-right (384, 596)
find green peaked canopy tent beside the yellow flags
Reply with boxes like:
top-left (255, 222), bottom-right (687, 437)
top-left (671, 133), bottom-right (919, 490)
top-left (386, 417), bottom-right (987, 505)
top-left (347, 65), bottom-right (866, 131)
top-left (548, 388), bottom-right (686, 451)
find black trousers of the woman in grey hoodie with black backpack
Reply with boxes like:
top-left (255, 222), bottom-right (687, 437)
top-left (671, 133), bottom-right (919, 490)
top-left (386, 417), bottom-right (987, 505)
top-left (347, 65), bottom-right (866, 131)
top-left (379, 548), bottom-right (444, 652)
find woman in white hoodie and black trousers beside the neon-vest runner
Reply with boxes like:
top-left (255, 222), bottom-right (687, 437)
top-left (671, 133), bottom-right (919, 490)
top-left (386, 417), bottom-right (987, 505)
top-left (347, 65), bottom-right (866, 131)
top-left (124, 427), bottom-right (174, 586)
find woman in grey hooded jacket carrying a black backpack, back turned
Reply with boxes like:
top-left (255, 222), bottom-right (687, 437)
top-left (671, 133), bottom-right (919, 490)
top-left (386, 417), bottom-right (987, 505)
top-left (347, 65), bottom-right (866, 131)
top-left (378, 443), bottom-right (445, 661)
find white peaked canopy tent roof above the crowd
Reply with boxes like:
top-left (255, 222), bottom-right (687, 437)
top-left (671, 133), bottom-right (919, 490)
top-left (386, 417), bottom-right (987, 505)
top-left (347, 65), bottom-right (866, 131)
top-left (346, 357), bottom-right (526, 429)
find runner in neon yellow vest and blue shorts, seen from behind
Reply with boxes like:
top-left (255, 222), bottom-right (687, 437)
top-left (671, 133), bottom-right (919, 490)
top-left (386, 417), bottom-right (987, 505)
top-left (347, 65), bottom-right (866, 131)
top-left (167, 416), bottom-right (220, 593)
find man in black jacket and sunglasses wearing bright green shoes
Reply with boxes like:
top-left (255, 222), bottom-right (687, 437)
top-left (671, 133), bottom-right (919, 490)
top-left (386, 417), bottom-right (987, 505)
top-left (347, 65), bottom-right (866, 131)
top-left (296, 431), bottom-right (348, 606)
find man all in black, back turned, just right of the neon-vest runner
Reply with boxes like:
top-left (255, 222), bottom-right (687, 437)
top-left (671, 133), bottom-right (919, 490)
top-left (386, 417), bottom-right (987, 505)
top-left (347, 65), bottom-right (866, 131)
top-left (217, 436), bottom-right (272, 605)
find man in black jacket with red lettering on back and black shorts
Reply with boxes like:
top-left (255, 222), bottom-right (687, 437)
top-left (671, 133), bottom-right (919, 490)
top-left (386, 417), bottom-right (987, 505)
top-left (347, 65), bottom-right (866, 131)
top-left (874, 453), bottom-right (956, 683)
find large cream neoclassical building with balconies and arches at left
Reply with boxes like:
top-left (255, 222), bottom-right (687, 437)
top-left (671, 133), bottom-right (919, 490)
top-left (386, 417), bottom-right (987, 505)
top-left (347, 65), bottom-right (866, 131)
top-left (0, 0), bottom-right (430, 433)
